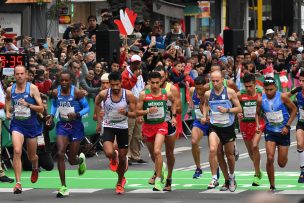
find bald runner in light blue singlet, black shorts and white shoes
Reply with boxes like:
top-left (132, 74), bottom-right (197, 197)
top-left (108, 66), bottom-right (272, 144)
top-left (202, 71), bottom-right (242, 192)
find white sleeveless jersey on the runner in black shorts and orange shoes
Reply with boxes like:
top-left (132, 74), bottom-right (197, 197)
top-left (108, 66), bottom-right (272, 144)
top-left (102, 88), bottom-right (128, 129)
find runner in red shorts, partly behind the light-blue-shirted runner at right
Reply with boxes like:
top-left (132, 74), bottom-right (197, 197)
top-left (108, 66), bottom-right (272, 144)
top-left (237, 74), bottom-right (265, 186)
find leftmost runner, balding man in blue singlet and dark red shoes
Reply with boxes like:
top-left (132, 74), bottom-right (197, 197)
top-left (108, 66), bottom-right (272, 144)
top-left (5, 65), bottom-right (44, 194)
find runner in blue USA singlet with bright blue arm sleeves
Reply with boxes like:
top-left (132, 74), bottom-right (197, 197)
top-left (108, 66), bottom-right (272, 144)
top-left (47, 70), bottom-right (90, 198)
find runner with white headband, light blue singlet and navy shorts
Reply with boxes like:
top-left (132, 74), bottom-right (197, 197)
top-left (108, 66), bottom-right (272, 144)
top-left (256, 77), bottom-right (297, 192)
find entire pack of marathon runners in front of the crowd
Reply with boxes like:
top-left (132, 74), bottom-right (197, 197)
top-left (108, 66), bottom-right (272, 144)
top-left (5, 63), bottom-right (304, 197)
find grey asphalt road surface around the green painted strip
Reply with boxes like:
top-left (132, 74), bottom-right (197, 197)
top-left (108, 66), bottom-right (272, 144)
top-left (0, 123), bottom-right (304, 203)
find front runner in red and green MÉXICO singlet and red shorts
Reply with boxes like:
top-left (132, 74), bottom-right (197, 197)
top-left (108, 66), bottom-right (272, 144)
top-left (137, 72), bottom-right (176, 191)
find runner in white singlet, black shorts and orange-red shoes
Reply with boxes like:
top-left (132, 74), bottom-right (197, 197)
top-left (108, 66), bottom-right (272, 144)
top-left (95, 72), bottom-right (136, 194)
